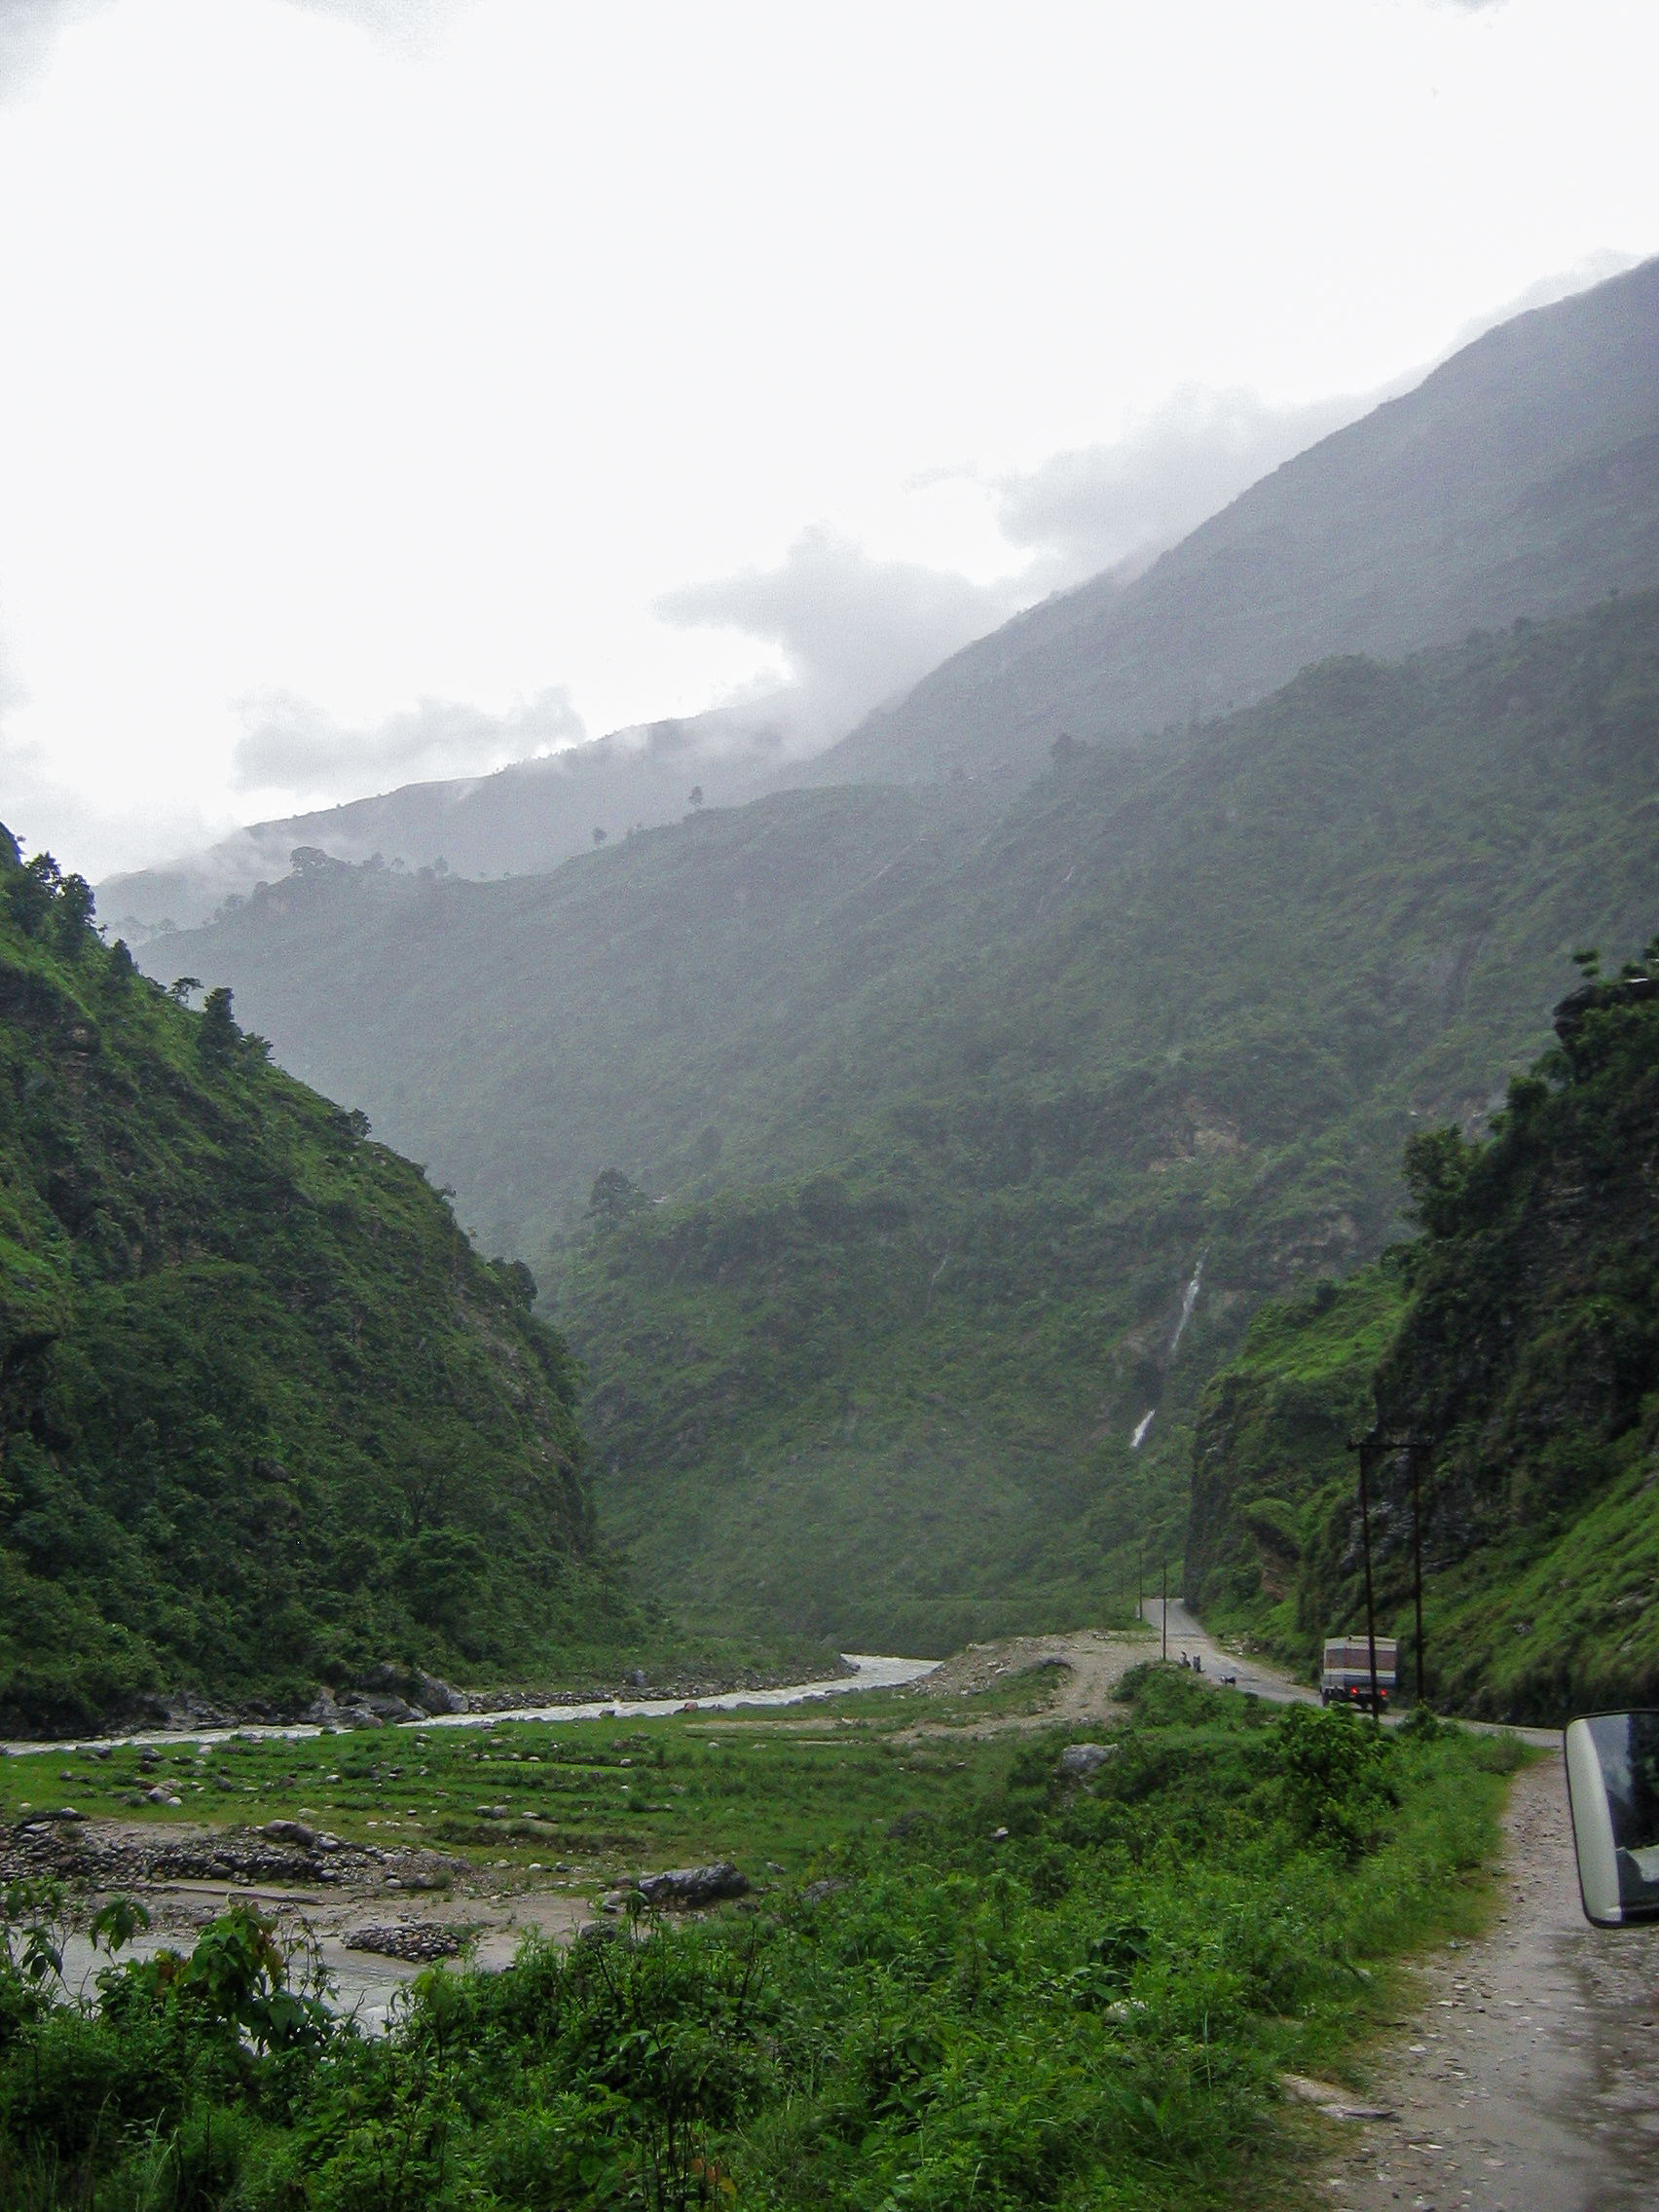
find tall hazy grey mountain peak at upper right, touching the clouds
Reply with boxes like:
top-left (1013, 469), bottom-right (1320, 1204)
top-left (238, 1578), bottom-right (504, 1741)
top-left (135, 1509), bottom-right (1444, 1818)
top-left (810, 261), bottom-right (1659, 794)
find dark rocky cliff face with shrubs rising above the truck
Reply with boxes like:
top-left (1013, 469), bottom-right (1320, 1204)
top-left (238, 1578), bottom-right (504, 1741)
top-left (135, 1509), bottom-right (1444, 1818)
top-left (1378, 976), bottom-right (1659, 1562)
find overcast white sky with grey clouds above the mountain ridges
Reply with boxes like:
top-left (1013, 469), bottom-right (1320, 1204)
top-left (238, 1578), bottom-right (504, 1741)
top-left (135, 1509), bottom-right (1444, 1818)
top-left (0, 0), bottom-right (1659, 876)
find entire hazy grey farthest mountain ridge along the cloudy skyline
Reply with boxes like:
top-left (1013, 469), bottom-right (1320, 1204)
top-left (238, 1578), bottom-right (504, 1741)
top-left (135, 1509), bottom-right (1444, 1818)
top-left (99, 261), bottom-right (1659, 942)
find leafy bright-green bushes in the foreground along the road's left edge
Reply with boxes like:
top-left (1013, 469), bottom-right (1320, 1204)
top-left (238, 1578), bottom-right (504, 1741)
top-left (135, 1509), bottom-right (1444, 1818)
top-left (0, 1668), bottom-right (1518, 2212)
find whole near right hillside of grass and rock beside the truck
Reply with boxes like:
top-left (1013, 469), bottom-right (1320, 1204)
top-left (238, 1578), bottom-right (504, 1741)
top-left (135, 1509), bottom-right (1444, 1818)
top-left (1186, 960), bottom-right (1659, 1721)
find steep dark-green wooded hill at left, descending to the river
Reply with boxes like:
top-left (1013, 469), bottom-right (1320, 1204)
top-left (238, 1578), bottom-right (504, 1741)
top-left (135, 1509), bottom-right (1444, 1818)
top-left (0, 834), bottom-right (640, 1727)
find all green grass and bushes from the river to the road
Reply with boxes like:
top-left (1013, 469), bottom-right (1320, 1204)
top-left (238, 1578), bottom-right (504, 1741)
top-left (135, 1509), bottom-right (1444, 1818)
top-left (0, 1666), bottom-right (1524, 2212)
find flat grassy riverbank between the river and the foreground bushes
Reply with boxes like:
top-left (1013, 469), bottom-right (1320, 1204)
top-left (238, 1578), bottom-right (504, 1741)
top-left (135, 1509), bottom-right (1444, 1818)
top-left (0, 1675), bottom-right (1052, 1887)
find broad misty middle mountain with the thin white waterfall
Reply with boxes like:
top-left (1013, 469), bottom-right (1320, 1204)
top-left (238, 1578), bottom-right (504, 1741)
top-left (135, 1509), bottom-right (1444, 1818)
top-left (152, 595), bottom-right (1659, 1648)
